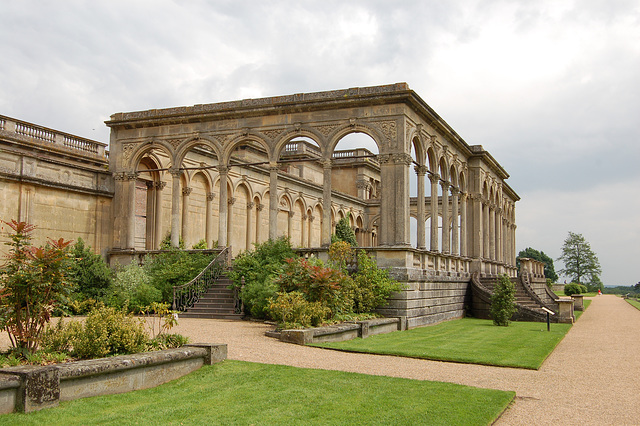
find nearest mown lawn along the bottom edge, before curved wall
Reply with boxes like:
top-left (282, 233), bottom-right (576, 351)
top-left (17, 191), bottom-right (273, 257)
top-left (0, 360), bottom-right (515, 425)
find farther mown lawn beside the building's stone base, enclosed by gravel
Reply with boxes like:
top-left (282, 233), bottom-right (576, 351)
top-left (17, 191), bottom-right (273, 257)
top-left (314, 318), bottom-right (571, 370)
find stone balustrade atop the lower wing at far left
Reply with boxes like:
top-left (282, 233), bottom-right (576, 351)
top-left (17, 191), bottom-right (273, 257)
top-left (0, 116), bottom-right (108, 160)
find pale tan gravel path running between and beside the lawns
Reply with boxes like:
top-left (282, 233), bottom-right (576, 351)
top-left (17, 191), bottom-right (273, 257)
top-left (174, 295), bottom-right (640, 425)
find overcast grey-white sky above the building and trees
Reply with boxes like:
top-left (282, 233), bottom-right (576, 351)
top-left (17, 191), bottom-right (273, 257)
top-left (0, 0), bottom-right (640, 285)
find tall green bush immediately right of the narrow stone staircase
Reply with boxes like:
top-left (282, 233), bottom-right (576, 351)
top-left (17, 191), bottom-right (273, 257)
top-left (229, 237), bottom-right (297, 318)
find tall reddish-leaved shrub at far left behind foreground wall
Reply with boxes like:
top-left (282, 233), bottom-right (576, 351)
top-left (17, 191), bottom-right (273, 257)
top-left (0, 220), bottom-right (71, 355)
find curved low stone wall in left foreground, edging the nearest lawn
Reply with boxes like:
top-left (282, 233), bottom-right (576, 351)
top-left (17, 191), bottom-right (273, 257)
top-left (0, 343), bottom-right (227, 414)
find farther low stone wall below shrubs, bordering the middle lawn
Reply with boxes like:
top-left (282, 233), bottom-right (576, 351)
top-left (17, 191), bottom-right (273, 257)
top-left (278, 318), bottom-right (406, 345)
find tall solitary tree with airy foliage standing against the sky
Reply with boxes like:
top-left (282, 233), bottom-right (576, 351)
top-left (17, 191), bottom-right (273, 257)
top-left (558, 232), bottom-right (602, 284)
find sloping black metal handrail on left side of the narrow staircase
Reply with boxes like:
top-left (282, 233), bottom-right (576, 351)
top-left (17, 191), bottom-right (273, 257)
top-left (172, 247), bottom-right (231, 312)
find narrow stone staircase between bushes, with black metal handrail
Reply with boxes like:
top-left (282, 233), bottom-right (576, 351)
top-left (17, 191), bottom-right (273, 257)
top-left (180, 275), bottom-right (244, 319)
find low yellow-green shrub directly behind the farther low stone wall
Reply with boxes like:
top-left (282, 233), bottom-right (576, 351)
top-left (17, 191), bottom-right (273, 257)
top-left (269, 291), bottom-right (330, 328)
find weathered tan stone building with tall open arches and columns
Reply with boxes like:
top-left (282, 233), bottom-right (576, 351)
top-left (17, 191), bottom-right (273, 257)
top-left (0, 83), bottom-right (519, 326)
